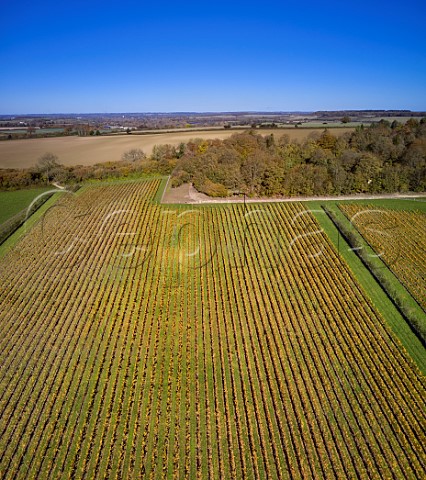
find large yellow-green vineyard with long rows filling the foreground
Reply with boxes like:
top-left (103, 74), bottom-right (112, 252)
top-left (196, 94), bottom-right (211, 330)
top-left (0, 180), bottom-right (426, 479)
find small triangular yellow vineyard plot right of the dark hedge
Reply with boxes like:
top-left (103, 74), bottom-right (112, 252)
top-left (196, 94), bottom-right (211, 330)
top-left (340, 204), bottom-right (426, 311)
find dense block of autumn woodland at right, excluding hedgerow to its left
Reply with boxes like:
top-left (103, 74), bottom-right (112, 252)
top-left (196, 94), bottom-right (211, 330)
top-left (173, 119), bottom-right (426, 196)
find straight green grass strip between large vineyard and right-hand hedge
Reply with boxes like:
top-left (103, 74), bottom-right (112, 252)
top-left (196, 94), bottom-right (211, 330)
top-left (306, 201), bottom-right (426, 374)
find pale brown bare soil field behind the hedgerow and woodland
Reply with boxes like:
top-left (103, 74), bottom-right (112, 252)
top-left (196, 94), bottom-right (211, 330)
top-left (0, 128), bottom-right (353, 168)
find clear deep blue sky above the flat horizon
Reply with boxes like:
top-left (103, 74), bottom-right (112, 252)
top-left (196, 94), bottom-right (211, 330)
top-left (0, 0), bottom-right (426, 114)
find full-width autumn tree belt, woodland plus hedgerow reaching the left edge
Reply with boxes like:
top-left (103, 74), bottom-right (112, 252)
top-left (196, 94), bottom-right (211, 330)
top-left (0, 118), bottom-right (426, 197)
